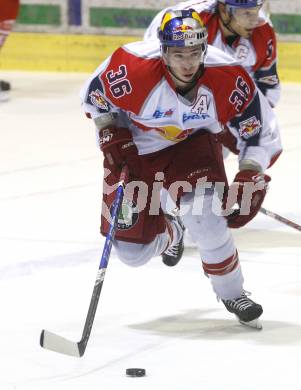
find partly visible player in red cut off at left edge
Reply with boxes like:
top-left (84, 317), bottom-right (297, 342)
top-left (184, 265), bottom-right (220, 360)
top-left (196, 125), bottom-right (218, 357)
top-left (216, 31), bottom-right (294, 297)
top-left (0, 0), bottom-right (20, 102)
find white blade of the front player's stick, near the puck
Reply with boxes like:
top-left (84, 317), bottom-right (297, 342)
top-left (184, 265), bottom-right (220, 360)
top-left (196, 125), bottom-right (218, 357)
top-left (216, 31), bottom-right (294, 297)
top-left (40, 329), bottom-right (82, 357)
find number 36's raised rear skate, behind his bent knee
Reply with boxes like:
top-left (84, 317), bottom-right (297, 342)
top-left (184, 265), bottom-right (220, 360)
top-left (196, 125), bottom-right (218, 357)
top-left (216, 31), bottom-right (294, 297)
top-left (162, 214), bottom-right (185, 267)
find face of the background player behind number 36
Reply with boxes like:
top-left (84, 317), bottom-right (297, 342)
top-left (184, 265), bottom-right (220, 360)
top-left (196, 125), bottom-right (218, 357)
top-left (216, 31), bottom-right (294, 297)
top-left (231, 6), bottom-right (261, 38)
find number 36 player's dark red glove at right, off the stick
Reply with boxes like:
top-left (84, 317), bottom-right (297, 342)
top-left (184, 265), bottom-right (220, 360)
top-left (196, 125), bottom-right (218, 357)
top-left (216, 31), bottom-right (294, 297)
top-left (223, 170), bottom-right (271, 229)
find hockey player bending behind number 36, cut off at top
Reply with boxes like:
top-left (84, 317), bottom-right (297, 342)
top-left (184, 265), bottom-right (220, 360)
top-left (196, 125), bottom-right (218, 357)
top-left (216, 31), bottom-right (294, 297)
top-left (144, 0), bottom-right (280, 107)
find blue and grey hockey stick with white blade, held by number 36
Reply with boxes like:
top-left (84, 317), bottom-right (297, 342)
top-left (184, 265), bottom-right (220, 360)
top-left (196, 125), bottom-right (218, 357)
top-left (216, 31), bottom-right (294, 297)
top-left (40, 166), bottom-right (128, 357)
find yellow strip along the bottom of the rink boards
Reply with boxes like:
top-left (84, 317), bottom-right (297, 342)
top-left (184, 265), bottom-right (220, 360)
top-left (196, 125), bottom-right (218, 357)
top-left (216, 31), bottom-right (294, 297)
top-left (0, 32), bottom-right (301, 82)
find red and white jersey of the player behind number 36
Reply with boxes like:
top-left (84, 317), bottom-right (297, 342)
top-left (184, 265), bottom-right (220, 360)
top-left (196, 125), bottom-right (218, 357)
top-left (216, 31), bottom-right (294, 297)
top-left (144, 0), bottom-right (280, 107)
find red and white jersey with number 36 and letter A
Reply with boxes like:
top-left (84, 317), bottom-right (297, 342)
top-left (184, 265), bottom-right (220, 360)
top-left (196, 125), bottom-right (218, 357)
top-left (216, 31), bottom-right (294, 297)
top-left (81, 41), bottom-right (281, 169)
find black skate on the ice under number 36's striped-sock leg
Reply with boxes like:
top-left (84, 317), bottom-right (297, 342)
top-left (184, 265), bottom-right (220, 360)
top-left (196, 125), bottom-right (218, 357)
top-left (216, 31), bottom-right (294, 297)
top-left (222, 292), bottom-right (263, 329)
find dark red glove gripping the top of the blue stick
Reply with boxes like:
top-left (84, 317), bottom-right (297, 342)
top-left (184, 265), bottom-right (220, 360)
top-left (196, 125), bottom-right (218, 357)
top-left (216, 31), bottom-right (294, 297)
top-left (99, 127), bottom-right (141, 178)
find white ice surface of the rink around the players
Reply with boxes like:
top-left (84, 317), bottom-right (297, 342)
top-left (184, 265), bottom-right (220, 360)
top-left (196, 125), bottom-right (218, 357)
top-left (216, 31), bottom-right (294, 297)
top-left (0, 72), bottom-right (301, 390)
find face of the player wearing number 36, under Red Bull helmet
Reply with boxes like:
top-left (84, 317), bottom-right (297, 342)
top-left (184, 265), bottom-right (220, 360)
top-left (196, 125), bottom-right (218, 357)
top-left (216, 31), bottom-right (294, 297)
top-left (163, 46), bottom-right (202, 87)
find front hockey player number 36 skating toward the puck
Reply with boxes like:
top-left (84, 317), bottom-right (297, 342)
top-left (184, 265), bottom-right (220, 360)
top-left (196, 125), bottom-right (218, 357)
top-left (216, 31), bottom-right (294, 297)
top-left (81, 9), bottom-right (281, 325)
